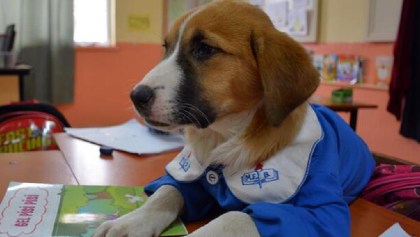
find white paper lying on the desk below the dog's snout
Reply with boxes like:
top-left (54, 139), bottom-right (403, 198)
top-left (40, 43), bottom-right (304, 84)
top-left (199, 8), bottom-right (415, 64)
top-left (66, 119), bottom-right (184, 154)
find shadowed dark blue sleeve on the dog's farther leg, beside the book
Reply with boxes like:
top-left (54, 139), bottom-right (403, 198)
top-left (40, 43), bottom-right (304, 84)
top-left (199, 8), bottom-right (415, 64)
top-left (144, 174), bottom-right (218, 221)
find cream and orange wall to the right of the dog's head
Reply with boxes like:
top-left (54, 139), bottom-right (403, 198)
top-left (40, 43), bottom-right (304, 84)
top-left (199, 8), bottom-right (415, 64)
top-left (305, 0), bottom-right (420, 163)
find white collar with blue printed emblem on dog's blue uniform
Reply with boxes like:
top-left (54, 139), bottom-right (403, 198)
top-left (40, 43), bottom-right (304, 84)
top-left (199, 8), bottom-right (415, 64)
top-left (166, 107), bottom-right (323, 203)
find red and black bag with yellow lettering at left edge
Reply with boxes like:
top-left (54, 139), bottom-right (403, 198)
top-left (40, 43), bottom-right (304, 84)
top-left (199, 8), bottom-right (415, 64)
top-left (0, 103), bottom-right (70, 153)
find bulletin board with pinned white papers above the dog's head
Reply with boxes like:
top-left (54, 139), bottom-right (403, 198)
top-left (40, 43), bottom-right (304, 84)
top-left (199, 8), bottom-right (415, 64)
top-left (250, 0), bottom-right (321, 43)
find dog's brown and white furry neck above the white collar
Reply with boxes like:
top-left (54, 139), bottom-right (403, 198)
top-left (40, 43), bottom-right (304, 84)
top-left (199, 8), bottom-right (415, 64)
top-left (186, 103), bottom-right (307, 169)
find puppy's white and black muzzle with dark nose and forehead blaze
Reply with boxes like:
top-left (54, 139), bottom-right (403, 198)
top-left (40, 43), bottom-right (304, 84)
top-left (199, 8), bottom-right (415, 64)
top-left (132, 8), bottom-right (216, 130)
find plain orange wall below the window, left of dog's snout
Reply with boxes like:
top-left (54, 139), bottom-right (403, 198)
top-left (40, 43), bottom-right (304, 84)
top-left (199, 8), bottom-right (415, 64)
top-left (57, 43), bottom-right (162, 127)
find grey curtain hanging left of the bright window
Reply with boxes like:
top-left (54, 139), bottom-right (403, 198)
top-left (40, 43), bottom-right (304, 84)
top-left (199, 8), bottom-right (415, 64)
top-left (0, 0), bottom-right (75, 104)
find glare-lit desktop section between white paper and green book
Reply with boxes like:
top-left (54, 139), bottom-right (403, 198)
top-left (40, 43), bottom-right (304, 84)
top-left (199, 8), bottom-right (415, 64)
top-left (54, 133), bottom-right (178, 185)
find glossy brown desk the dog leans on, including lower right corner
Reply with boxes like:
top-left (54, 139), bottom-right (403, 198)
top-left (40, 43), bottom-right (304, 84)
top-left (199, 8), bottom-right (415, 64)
top-left (54, 133), bottom-right (420, 237)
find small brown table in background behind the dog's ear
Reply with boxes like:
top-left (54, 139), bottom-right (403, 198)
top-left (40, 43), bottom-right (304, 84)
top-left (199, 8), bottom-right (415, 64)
top-left (310, 95), bottom-right (378, 131)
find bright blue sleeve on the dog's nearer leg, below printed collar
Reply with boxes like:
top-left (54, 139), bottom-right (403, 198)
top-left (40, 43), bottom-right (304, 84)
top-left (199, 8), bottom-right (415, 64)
top-left (244, 173), bottom-right (350, 237)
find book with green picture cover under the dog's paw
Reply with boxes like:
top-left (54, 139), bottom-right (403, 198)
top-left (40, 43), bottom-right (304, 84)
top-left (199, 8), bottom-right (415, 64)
top-left (0, 182), bottom-right (187, 237)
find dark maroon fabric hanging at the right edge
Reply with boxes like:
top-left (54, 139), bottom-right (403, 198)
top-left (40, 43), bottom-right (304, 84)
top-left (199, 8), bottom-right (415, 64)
top-left (387, 0), bottom-right (420, 142)
